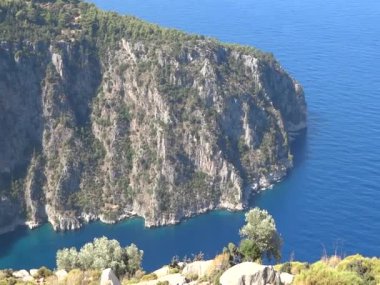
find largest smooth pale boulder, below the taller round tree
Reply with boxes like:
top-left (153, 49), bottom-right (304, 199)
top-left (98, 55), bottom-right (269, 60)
top-left (220, 262), bottom-right (281, 285)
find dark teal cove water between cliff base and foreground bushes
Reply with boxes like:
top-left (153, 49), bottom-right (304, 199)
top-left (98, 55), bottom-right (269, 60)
top-left (0, 211), bottom-right (244, 270)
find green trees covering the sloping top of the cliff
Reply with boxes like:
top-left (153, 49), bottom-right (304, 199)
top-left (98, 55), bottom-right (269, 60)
top-left (0, 0), bottom-right (273, 59)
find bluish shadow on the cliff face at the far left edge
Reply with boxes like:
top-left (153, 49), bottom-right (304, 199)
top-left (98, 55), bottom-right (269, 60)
top-left (0, 47), bottom-right (44, 192)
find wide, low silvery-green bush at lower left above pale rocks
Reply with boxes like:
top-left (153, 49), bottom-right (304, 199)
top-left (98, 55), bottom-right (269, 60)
top-left (57, 237), bottom-right (143, 276)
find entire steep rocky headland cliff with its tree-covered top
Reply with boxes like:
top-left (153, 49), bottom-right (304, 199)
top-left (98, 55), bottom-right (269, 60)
top-left (0, 0), bottom-right (306, 230)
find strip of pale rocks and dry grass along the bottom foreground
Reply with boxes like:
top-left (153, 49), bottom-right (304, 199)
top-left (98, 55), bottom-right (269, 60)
top-left (0, 260), bottom-right (294, 285)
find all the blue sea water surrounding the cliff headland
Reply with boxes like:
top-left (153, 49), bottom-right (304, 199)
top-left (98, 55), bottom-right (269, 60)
top-left (0, 0), bottom-right (380, 270)
